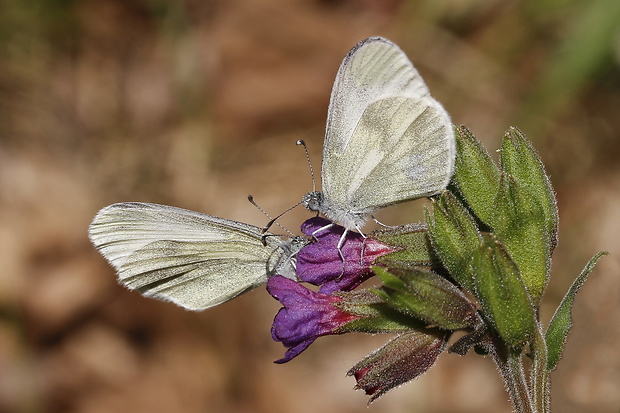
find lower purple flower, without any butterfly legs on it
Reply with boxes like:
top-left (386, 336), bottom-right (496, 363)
top-left (267, 275), bottom-right (361, 363)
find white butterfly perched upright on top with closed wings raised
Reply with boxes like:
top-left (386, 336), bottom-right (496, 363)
top-left (302, 37), bottom-right (456, 241)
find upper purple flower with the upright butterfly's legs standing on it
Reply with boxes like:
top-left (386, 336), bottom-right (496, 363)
top-left (297, 217), bottom-right (395, 294)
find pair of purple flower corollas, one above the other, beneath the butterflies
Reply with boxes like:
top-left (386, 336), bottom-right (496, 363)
top-left (267, 217), bottom-right (395, 363)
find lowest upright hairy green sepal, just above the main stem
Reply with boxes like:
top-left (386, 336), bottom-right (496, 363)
top-left (472, 236), bottom-right (535, 350)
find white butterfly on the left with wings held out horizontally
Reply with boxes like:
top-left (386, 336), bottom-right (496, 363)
top-left (89, 202), bottom-right (308, 310)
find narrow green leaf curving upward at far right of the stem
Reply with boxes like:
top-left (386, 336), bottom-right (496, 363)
top-left (545, 251), bottom-right (609, 371)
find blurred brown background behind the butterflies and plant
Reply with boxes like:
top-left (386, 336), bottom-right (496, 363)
top-left (0, 0), bottom-right (620, 413)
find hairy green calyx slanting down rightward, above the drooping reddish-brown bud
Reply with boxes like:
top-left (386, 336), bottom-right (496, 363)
top-left (373, 267), bottom-right (482, 330)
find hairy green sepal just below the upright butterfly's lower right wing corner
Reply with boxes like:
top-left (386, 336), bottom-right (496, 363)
top-left (426, 191), bottom-right (482, 291)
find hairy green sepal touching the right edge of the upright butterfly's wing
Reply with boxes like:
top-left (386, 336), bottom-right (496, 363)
top-left (452, 126), bottom-right (500, 222)
